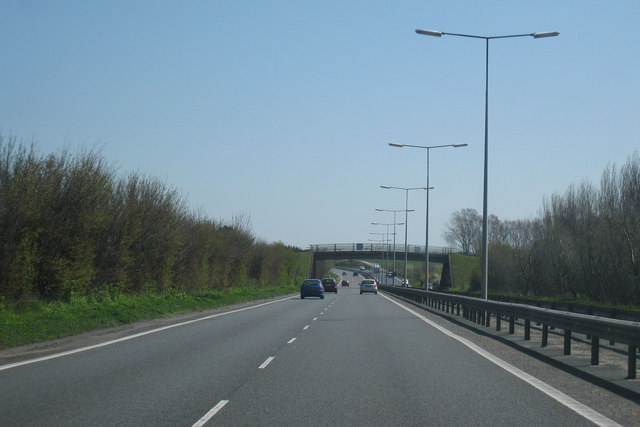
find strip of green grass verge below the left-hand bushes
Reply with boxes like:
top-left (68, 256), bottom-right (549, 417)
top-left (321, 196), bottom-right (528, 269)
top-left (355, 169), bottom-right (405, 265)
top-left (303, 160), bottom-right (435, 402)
top-left (0, 285), bottom-right (299, 349)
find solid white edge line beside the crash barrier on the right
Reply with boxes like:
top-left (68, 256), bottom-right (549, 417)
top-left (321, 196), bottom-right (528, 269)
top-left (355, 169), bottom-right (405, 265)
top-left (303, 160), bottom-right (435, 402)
top-left (382, 295), bottom-right (620, 426)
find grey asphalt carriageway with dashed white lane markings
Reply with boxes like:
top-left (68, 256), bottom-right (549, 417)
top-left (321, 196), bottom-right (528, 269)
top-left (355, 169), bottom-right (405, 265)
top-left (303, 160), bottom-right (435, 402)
top-left (0, 275), bottom-right (637, 426)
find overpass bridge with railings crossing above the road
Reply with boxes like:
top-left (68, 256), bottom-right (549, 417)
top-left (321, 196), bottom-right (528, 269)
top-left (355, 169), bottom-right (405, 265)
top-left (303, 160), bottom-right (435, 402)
top-left (309, 243), bottom-right (455, 287)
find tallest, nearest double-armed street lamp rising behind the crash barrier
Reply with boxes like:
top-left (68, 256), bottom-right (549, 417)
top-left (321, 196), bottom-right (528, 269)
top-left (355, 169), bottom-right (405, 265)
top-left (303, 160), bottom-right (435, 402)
top-left (416, 30), bottom-right (560, 299)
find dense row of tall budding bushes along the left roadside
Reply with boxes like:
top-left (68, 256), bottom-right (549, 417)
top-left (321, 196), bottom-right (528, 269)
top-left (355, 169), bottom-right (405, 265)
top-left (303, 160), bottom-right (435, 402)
top-left (0, 135), bottom-right (307, 300)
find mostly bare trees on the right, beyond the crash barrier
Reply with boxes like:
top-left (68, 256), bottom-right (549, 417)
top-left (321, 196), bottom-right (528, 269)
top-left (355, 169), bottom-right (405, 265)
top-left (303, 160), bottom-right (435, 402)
top-left (444, 152), bottom-right (640, 305)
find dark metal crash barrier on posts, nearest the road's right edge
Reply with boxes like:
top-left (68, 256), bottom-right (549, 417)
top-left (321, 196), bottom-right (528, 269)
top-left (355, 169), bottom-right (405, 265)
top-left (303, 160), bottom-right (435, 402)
top-left (380, 286), bottom-right (640, 379)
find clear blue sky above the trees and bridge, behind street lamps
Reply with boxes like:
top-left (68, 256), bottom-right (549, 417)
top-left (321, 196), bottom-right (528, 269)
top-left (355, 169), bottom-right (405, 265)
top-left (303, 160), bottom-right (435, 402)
top-left (0, 0), bottom-right (640, 247)
